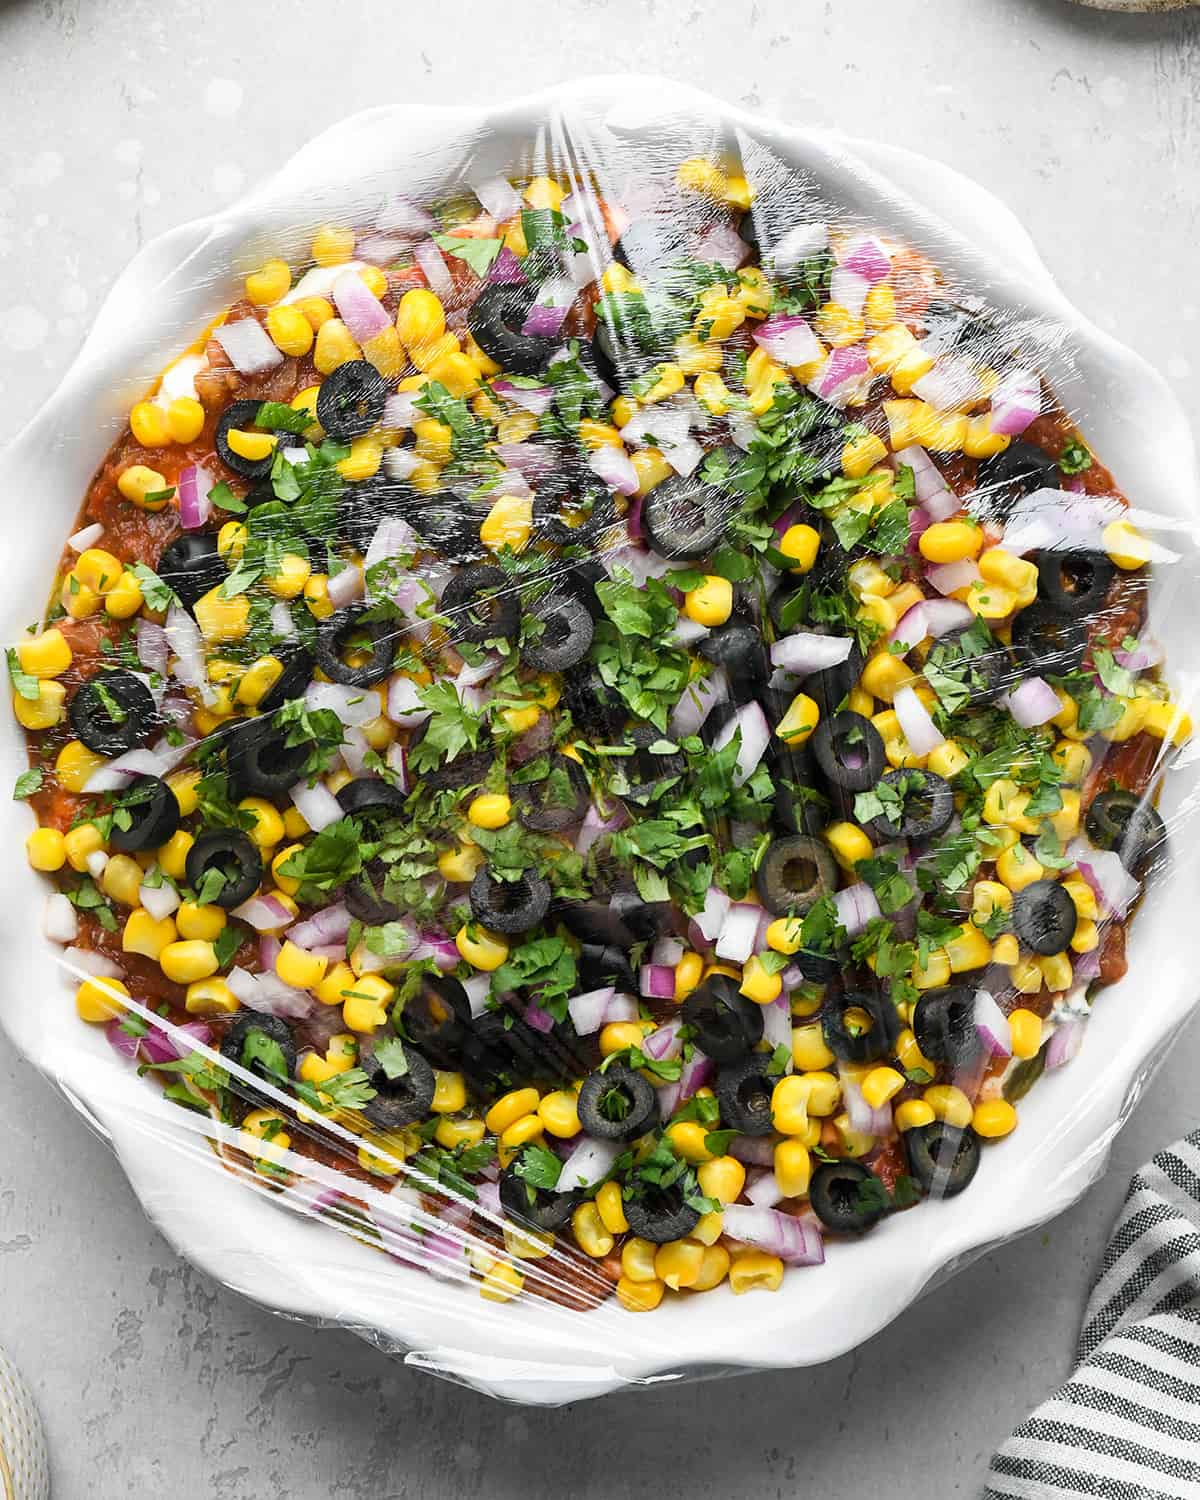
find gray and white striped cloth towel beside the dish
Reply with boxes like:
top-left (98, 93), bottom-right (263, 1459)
top-left (986, 1131), bottom-right (1200, 1500)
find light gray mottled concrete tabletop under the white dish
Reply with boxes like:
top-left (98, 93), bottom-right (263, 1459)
top-left (0, 0), bottom-right (1200, 1500)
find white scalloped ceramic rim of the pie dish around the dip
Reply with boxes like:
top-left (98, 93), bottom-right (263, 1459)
top-left (0, 78), bottom-right (1200, 1404)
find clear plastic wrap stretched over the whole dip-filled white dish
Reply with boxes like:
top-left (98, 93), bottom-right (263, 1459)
top-left (0, 81), bottom-right (1197, 1401)
